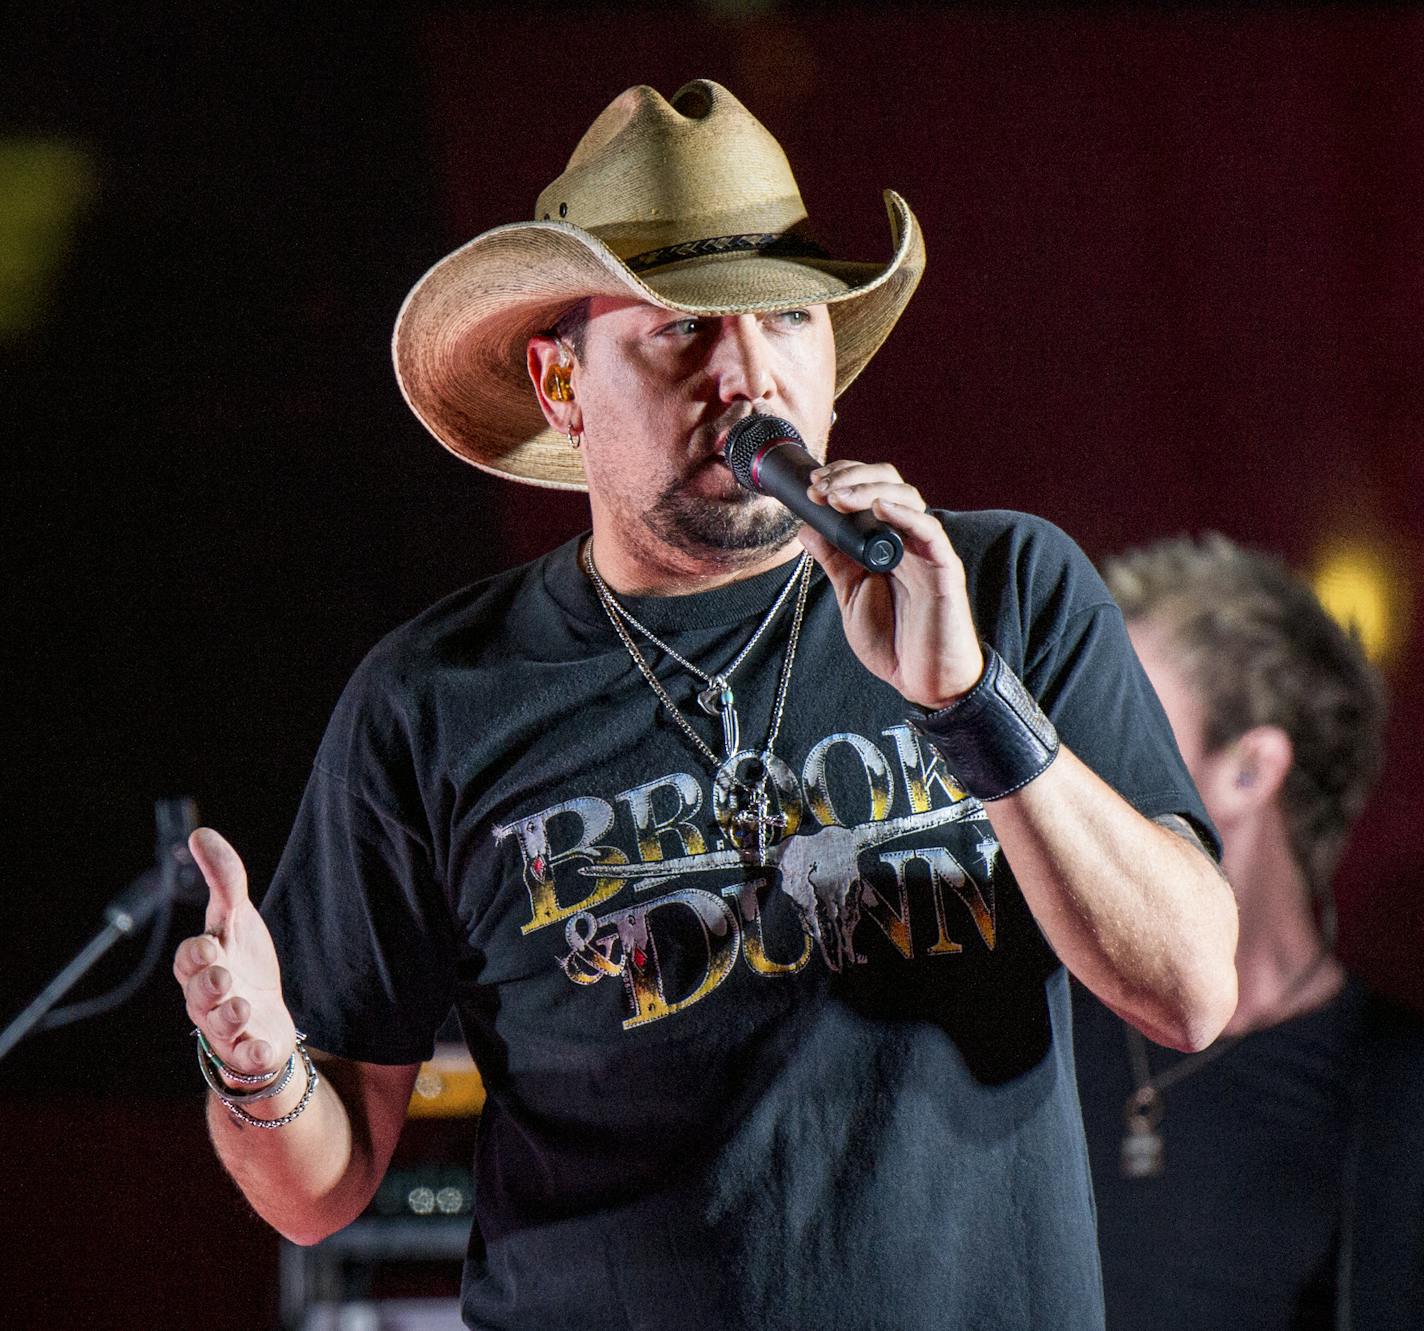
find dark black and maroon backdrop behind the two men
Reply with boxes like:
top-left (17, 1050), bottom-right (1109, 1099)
top-left (0, 3), bottom-right (1424, 1331)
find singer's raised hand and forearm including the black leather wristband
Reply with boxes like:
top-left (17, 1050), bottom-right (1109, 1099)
top-left (800, 475), bottom-right (1236, 1048)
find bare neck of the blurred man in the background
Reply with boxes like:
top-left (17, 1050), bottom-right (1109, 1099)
top-left (1222, 826), bottom-right (1346, 1036)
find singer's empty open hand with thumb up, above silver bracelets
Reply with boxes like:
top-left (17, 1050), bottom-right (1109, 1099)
top-left (174, 827), bottom-right (296, 1087)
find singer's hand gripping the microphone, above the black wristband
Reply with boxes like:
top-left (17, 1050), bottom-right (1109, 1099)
top-left (800, 458), bottom-right (984, 712)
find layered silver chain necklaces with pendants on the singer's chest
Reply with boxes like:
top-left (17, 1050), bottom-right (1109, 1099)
top-left (584, 540), bottom-right (810, 866)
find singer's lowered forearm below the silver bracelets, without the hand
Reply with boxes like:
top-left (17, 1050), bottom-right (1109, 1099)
top-left (208, 1059), bottom-right (409, 1244)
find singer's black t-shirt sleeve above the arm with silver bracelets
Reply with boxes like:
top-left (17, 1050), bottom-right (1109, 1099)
top-left (262, 660), bottom-right (454, 1063)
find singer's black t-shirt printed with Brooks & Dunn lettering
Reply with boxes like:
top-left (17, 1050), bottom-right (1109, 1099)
top-left (263, 512), bottom-right (1208, 1331)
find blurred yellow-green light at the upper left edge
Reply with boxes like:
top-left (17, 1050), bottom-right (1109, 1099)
top-left (0, 138), bottom-right (97, 340)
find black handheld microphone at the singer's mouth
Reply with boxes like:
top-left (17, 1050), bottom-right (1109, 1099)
top-left (722, 416), bottom-right (904, 574)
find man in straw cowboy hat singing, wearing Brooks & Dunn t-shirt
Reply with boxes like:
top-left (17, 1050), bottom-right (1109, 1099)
top-left (175, 81), bottom-right (1236, 1331)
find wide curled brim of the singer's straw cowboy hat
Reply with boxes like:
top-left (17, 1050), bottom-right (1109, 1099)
top-left (392, 189), bottom-right (924, 490)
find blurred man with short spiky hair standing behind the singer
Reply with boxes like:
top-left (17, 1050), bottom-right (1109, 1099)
top-left (1075, 535), bottom-right (1424, 1331)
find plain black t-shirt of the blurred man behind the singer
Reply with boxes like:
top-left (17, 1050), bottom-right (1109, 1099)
top-left (1074, 981), bottom-right (1361, 1331)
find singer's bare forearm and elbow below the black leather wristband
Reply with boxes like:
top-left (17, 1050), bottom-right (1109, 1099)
top-left (985, 749), bottom-right (1236, 1049)
